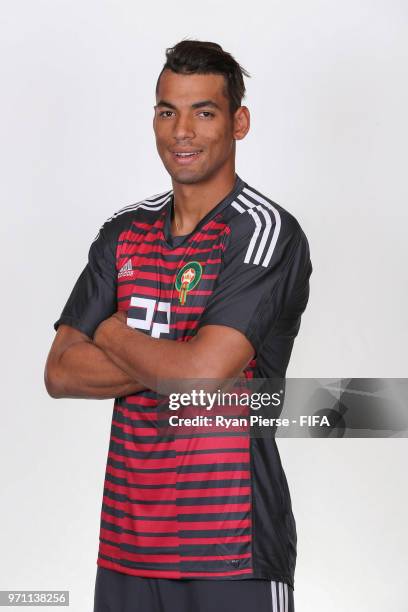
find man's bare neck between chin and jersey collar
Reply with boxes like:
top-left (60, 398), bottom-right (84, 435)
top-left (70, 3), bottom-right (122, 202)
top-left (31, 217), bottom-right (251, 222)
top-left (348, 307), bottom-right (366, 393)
top-left (172, 168), bottom-right (236, 236)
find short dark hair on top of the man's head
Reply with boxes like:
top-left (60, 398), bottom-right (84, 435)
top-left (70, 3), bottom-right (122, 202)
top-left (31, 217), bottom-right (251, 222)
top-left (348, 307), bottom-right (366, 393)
top-left (156, 40), bottom-right (250, 113)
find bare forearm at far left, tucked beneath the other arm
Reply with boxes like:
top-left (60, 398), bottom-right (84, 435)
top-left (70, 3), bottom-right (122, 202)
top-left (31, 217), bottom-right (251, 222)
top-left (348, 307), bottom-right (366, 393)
top-left (45, 341), bottom-right (144, 399)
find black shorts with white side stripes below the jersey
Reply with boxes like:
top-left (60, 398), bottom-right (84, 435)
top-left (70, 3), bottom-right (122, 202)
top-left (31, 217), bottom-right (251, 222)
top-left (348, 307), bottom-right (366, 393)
top-left (94, 567), bottom-right (294, 612)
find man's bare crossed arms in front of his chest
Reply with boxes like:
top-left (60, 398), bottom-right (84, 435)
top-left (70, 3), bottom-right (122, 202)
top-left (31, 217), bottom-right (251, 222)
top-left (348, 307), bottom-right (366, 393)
top-left (45, 312), bottom-right (254, 399)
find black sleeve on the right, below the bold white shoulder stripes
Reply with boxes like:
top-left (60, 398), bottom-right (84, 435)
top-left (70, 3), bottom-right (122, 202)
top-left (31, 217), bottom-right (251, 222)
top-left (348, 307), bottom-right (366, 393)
top-left (200, 218), bottom-right (312, 353)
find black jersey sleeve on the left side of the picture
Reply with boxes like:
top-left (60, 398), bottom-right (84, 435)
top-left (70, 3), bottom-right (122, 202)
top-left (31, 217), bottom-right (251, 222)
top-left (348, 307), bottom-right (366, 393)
top-left (54, 222), bottom-right (117, 338)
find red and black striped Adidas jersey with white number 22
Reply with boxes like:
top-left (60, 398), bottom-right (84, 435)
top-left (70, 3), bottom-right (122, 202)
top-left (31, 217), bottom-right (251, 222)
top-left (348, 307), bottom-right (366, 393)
top-left (55, 177), bottom-right (312, 586)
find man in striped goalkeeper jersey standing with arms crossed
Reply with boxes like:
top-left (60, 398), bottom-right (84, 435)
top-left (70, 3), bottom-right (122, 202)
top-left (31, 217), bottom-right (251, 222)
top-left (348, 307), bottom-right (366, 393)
top-left (45, 40), bottom-right (311, 612)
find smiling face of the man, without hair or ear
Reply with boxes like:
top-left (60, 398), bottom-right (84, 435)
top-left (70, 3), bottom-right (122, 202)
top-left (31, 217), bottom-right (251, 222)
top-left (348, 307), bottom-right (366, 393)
top-left (153, 70), bottom-right (239, 184)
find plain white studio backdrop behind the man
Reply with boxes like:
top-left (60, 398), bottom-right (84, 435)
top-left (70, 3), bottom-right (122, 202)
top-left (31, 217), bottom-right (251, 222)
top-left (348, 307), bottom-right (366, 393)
top-left (0, 0), bottom-right (408, 612)
